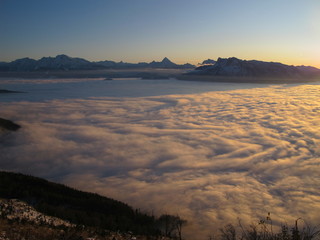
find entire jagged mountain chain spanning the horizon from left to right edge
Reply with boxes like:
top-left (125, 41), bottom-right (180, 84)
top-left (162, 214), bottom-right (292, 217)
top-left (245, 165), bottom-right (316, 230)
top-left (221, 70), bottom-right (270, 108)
top-left (0, 55), bottom-right (320, 81)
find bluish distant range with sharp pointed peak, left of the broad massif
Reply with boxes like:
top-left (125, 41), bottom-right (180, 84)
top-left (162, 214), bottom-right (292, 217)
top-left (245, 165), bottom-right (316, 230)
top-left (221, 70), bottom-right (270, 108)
top-left (0, 54), bottom-right (195, 72)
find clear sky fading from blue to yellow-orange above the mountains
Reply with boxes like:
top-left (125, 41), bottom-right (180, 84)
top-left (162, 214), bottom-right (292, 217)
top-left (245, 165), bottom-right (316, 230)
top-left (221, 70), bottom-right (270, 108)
top-left (0, 0), bottom-right (320, 67)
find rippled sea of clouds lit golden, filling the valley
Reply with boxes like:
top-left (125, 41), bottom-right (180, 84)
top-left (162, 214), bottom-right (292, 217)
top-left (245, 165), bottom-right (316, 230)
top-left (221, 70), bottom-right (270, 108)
top-left (0, 81), bottom-right (320, 239)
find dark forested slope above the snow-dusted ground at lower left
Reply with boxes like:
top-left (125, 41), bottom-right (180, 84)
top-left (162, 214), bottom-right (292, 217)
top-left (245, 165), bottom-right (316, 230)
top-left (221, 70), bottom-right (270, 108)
top-left (0, 171), bottom-right (158, 235)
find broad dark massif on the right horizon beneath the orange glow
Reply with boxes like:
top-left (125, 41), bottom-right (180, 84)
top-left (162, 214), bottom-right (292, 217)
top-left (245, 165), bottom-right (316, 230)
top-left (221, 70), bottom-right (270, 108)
top-left (189, 57), bottom-right (320, 78)
